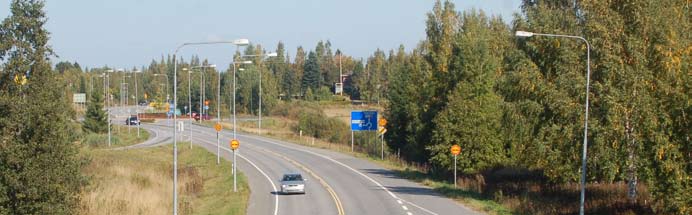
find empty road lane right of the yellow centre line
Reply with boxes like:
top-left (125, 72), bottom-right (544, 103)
top-left (187, 121), bottom-right (478, 215)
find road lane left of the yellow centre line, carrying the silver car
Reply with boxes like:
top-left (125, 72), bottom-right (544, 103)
top-left (143, 123), bottom-right (339, 214)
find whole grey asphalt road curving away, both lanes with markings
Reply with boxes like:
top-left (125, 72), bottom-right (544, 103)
top-left (113, 105), bottom-right (479, 215)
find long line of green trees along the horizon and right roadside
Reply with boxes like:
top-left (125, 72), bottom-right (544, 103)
top-left (51, 0), bottom-right (692, 213)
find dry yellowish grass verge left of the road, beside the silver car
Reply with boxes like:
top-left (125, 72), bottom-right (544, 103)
top-left (79, 124), bottom-right (250, 214)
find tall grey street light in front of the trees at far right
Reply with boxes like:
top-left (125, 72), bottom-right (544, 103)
top-left (515, 31), bottom-right (591, 215)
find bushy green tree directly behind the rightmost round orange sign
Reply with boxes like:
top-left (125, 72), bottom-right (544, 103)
top-left (428, 11), bottom-right (509, 174)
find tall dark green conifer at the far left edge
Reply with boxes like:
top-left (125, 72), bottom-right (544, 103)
top-left (0, 0), bottom-right (84, 214)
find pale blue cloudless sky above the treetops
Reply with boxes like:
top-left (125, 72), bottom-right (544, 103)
top-left (0, 0), bottom-right (520, 68)
